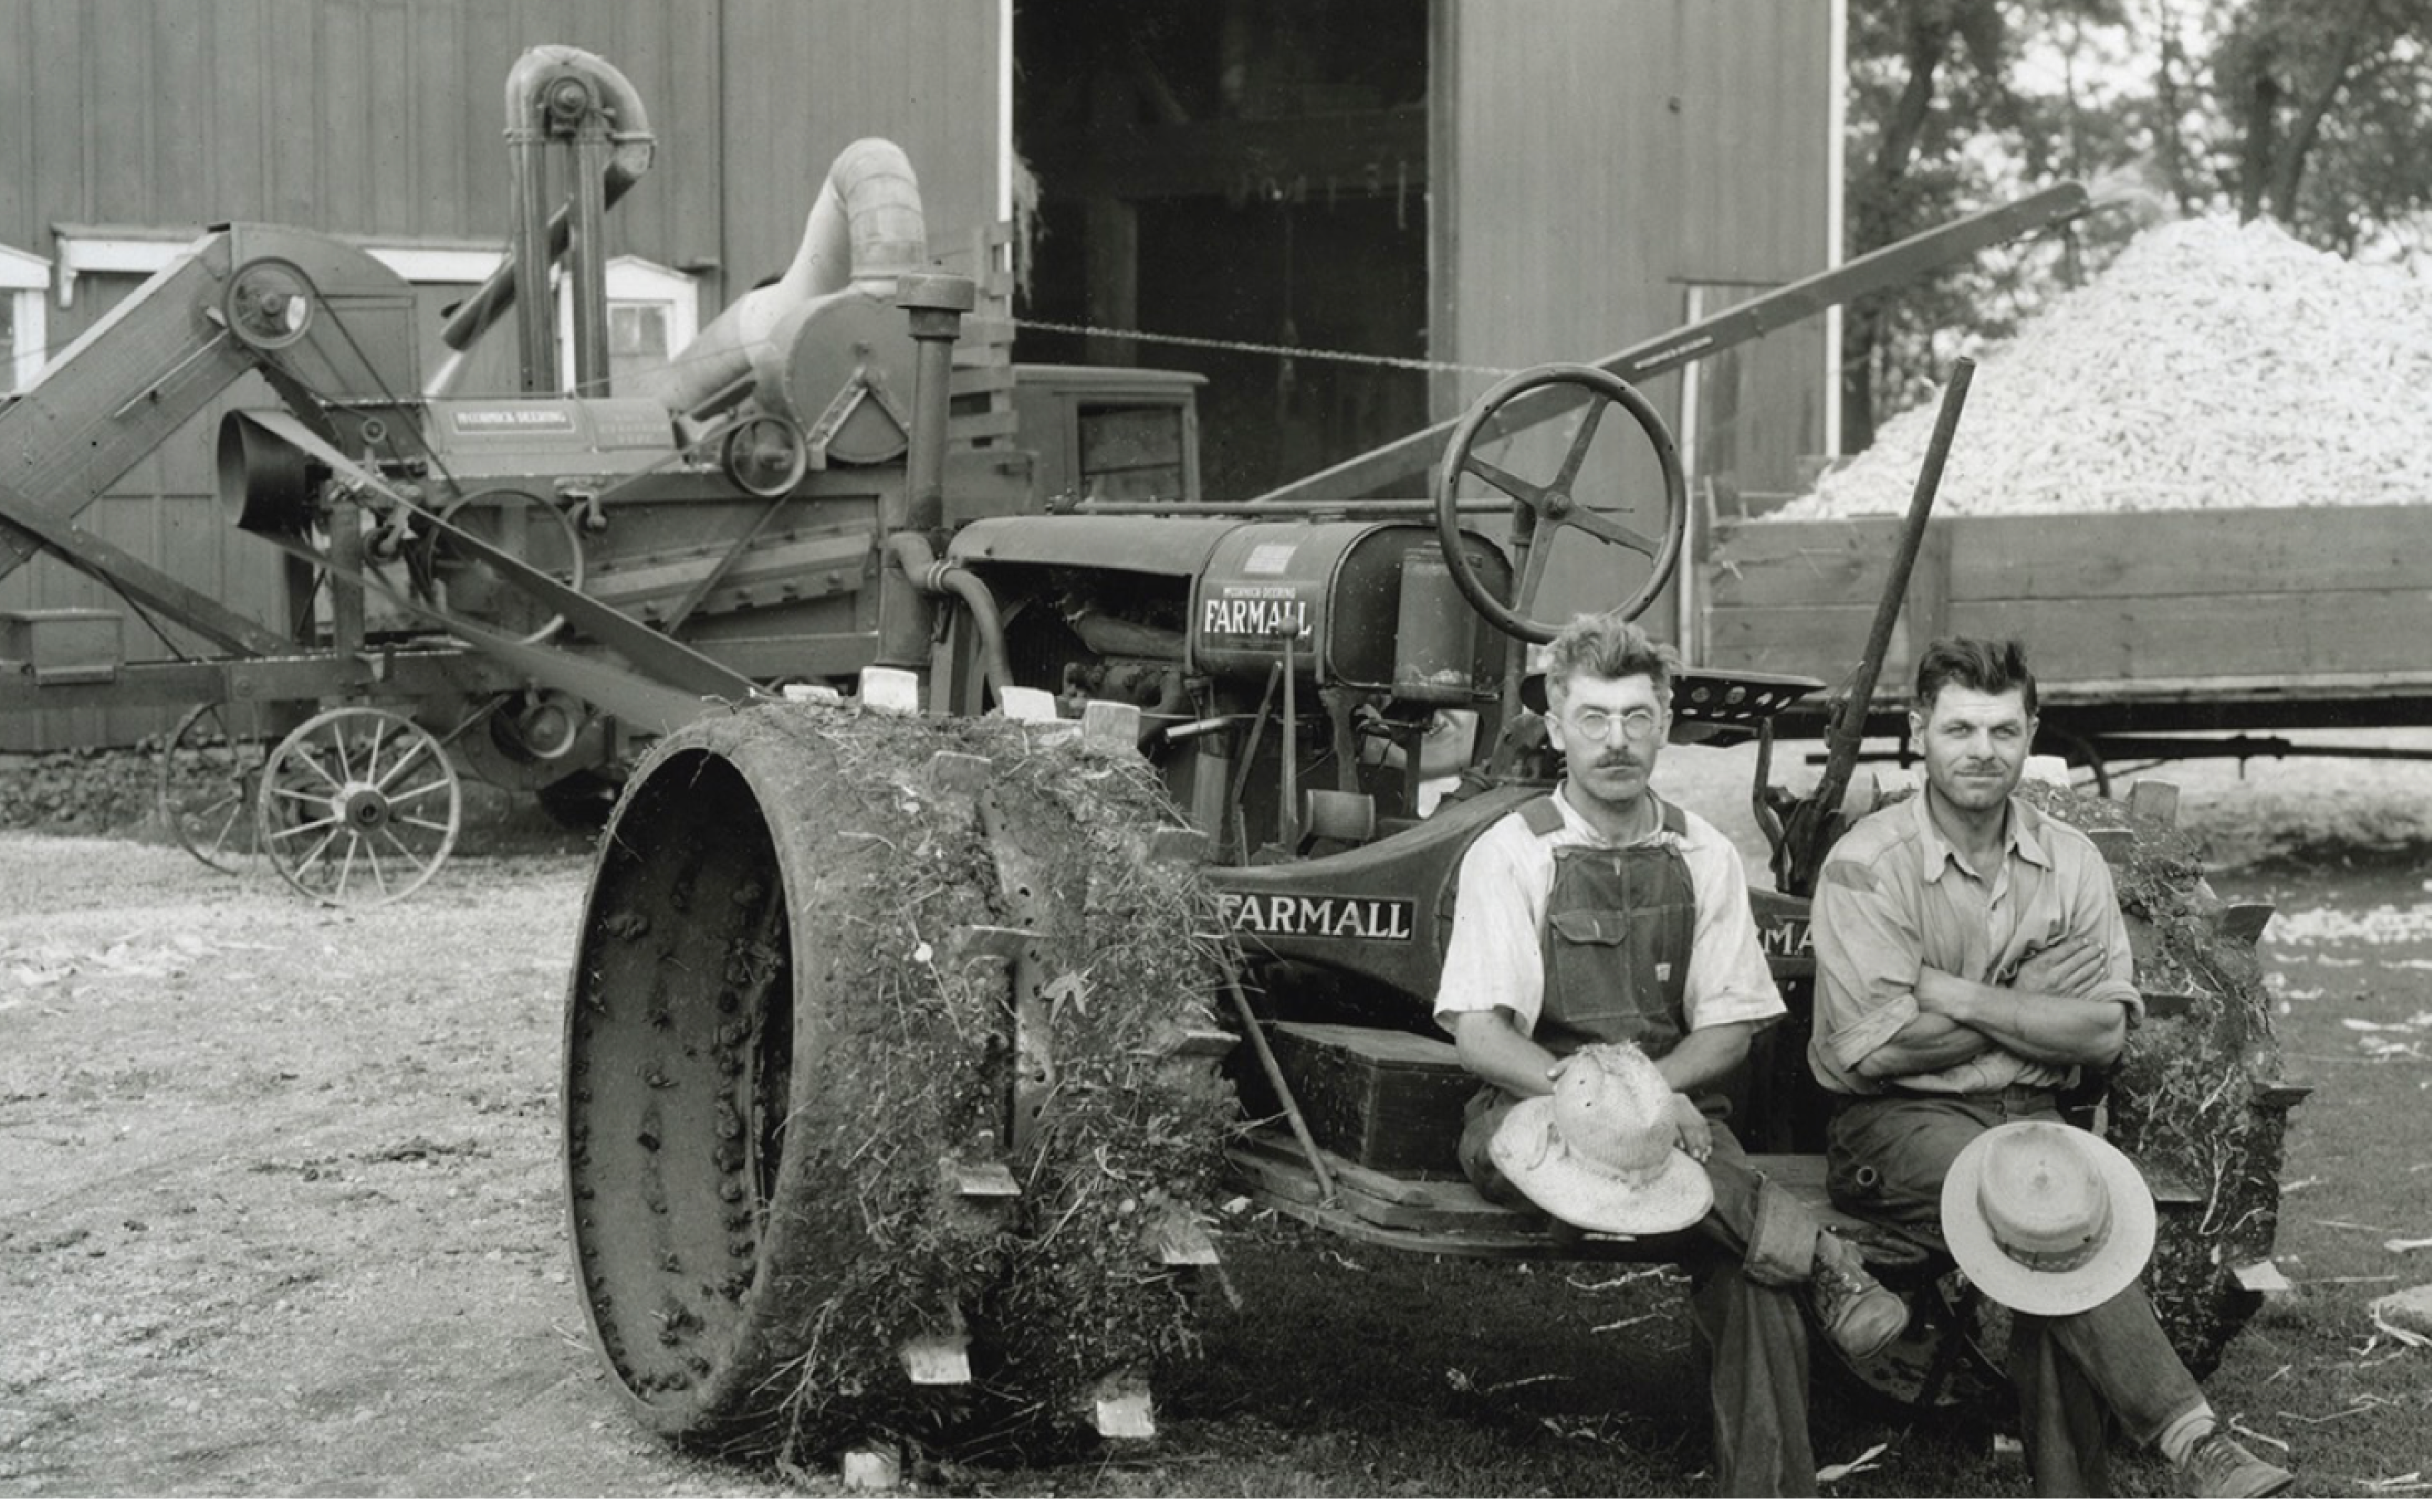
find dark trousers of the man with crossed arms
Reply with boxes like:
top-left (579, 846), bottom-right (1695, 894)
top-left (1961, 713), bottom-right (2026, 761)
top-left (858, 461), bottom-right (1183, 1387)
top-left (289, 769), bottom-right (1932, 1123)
top-left (1826, 1088), bottom-right (2203, 1499)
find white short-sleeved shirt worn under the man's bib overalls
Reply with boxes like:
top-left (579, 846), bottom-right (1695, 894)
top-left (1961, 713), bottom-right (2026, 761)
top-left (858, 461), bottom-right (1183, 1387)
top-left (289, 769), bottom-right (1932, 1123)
top-left (1435, 781), bottom-right (1785, 1037)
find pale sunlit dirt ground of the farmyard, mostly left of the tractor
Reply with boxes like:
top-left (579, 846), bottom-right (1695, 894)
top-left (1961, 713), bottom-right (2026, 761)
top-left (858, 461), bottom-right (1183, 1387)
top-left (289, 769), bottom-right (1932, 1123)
top-left (0, 739), bottom-right (2432, 1499)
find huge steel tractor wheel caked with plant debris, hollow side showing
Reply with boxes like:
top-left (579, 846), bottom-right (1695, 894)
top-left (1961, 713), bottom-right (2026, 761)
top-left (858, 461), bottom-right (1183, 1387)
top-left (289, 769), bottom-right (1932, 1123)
top-left (562, 703), bottom-right (1235, 1460)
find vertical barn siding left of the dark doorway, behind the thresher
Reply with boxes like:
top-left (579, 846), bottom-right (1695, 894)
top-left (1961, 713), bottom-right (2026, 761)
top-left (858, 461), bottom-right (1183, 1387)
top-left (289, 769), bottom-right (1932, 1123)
top-left (0, 0), bottom-right (1002, 750)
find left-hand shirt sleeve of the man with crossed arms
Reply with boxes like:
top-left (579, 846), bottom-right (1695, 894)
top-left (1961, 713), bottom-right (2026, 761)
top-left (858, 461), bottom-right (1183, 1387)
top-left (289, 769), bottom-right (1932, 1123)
top-left (1807, 857), bottom-right (1924, 1093)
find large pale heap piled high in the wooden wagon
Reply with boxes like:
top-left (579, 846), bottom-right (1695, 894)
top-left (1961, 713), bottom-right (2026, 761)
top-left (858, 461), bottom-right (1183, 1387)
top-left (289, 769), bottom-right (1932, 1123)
top-left (1775, 219), bottom-right (2432, 521)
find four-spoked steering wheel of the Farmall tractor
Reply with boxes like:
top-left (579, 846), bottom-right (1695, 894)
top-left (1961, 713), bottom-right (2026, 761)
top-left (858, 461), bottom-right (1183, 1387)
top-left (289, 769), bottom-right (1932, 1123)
top-left (1435, 365), bottom-right (1688, 642)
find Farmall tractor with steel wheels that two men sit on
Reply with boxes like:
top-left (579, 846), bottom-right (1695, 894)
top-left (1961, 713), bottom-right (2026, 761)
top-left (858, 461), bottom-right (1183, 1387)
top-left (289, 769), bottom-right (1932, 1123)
top-left (547, 170), bottom-right (2298, 1450)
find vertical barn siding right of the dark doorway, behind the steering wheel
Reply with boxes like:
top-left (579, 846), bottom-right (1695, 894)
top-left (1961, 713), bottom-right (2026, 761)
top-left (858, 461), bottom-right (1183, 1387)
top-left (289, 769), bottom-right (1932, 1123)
top-left (1430, 0), bottom-right (1834, 637)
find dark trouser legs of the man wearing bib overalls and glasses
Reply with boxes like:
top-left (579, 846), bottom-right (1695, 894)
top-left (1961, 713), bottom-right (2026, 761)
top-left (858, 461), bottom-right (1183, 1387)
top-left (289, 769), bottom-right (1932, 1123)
top-left (1462, 1088), bottom-right (1817, 1499)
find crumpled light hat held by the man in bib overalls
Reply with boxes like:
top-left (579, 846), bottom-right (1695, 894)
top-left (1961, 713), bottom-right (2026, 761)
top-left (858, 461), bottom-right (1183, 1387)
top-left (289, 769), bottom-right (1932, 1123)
top-left (1488, 1044), bottom-right (1715, 1234)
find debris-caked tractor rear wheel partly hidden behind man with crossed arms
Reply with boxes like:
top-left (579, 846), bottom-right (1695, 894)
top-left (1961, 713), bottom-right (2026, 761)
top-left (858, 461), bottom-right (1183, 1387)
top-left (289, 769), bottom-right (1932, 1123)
top-left (1853, 784), bottom-right (2306, 1404)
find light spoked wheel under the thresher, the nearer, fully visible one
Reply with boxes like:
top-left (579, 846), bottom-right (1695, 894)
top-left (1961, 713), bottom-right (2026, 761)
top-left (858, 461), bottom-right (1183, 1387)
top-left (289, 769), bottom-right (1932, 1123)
top-left (258, 708), bottom-right (465, 905)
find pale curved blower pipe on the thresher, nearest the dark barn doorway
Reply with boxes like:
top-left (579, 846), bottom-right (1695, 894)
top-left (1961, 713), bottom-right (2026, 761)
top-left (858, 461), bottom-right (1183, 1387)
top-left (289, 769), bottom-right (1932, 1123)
top-left (627, 136), bottom-right (929, 411)
